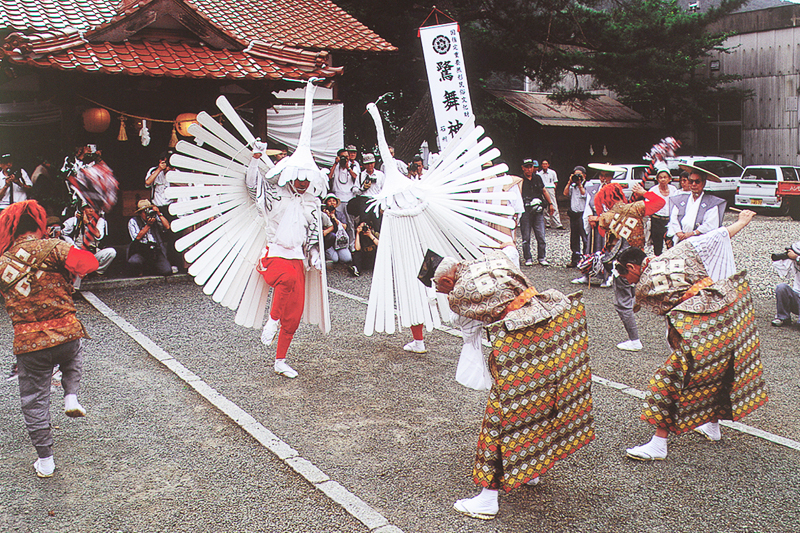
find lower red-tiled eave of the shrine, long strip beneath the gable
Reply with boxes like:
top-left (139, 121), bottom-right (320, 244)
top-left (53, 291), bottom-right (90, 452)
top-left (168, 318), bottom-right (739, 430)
top-left (0, 32), bottom-right (341, 79)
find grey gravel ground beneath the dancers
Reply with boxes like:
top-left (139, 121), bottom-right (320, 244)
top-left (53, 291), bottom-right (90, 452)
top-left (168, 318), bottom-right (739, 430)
top-left (0, 210), bottom-right (800, 533)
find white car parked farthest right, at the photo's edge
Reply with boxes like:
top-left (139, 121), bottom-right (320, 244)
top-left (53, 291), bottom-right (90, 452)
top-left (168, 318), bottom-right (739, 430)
top-left (736, 165), bottom-right (800, 215)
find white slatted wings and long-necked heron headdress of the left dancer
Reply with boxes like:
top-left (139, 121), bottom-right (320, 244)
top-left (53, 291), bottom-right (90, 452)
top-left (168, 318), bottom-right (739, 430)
top-left (166, 81), bottom-right (330, 333)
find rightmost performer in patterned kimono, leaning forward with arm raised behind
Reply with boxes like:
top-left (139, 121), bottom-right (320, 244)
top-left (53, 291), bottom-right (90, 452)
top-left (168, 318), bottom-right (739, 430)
top-left (620, 211), bottom-right (767, 461)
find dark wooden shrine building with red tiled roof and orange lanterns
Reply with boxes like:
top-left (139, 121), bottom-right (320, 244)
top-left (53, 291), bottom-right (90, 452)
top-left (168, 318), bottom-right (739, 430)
top-left (0, 0), bottom-right (395, 238)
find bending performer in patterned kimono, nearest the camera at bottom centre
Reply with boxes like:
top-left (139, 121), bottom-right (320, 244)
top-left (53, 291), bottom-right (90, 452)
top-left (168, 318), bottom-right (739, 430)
top-left (421, 252), bottom-right (594, 520)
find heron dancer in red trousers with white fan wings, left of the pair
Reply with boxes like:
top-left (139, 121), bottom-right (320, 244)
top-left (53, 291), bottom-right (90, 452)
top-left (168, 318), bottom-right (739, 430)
top-left (166, 80), bottom-right (330, 377)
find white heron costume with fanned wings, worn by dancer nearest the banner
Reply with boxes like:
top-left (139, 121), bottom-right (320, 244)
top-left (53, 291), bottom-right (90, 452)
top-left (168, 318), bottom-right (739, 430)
top-left (364, 104), bottom-right (514, 344)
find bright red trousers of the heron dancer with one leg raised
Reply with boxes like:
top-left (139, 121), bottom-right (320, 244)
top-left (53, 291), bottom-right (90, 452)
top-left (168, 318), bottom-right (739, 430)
top-left (261, 257), bottom-right (306, 359)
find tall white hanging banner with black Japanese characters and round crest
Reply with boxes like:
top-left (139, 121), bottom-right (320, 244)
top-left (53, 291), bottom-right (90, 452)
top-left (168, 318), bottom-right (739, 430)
top-left (419, 22), bottom-right (473, 151)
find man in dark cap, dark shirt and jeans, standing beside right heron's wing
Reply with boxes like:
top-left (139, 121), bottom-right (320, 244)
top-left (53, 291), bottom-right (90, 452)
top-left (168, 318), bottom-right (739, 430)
top-left (520, 159), bottom-right (555, 266)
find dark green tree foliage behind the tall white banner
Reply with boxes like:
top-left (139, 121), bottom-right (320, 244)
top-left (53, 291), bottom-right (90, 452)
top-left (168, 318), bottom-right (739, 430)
top-left (338, 0), bottom-right (747, 148)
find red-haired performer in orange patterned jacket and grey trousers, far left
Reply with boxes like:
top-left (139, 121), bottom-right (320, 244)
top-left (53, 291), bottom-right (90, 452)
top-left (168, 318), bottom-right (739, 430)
top-left (0, 200), bottom-right (97, 478)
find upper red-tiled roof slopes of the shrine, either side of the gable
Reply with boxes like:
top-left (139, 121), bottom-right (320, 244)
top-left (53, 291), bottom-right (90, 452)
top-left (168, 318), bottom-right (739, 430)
top-left (0, 0), bottom-right (396, 52)
